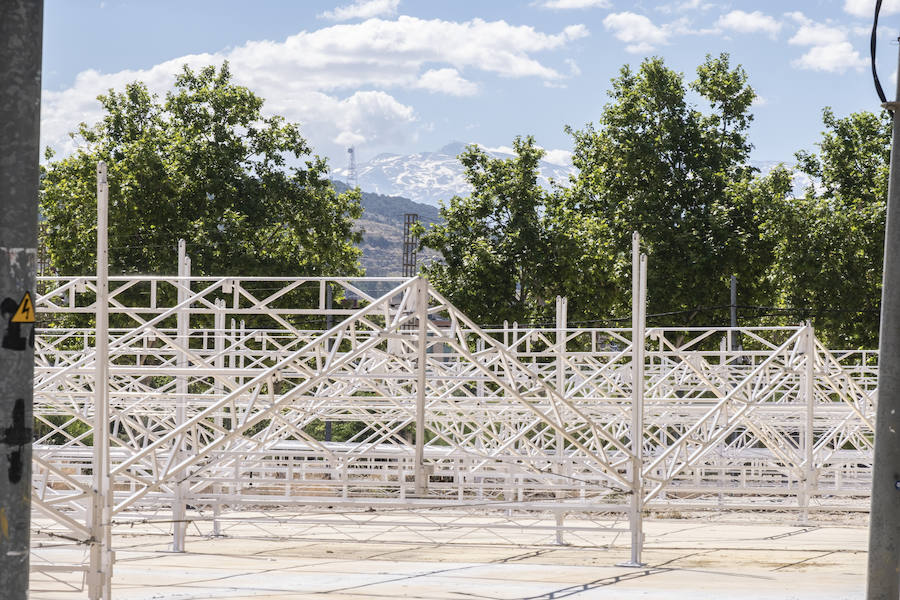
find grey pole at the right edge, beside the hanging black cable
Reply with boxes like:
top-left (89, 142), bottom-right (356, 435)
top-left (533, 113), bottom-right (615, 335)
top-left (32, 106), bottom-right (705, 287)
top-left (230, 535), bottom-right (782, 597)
top-left (866, 38), bottom-right (900, 600)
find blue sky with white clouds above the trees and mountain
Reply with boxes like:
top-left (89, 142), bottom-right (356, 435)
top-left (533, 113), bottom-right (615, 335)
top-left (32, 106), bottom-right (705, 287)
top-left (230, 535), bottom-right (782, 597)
top-left (42, 0), bottom-right (900, 167)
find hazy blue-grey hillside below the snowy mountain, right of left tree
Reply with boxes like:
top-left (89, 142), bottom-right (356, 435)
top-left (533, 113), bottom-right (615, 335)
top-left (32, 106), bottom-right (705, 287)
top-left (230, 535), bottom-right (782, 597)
top-left (334, 181), bottom-right (440, 277)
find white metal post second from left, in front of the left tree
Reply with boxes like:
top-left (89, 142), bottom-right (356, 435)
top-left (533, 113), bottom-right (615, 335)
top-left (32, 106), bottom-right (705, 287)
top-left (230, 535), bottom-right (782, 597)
top-left (172, 240), bottom-right (191, 552)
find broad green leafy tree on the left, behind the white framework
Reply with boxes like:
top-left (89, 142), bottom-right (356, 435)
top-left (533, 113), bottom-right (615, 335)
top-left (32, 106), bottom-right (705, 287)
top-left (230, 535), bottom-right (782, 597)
top-left (41, 63), bottom-right (361, 276)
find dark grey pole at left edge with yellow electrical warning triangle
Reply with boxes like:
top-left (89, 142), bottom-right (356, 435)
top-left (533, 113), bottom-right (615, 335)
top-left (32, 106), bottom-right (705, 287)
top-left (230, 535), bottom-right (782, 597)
top-left (0, 0), bottom-right (44, 600)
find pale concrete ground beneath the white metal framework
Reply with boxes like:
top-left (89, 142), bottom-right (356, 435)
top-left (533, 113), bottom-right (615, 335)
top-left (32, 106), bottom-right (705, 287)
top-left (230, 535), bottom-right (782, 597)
top-left (30, 514), bottom-right (868, 600)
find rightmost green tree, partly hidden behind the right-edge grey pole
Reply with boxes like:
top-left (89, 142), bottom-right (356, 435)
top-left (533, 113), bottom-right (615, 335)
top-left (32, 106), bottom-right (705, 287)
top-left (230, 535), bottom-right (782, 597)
top-left (771, 108), bottom-right (891, 348)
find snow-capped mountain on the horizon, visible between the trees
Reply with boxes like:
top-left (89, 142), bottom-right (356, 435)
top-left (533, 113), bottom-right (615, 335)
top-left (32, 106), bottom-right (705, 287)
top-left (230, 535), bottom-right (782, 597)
top-left (333, 142), bottom-right (810, 206)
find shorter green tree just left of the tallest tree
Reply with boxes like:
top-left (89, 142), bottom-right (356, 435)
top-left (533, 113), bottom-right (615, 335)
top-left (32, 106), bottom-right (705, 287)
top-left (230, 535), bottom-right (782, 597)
top-left (421, 136), bottom-right (611, 324)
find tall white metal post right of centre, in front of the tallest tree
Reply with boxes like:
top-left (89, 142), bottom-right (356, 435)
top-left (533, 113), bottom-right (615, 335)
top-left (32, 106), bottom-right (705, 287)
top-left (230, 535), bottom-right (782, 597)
top-left (623, 232), bottom-right (646, 567)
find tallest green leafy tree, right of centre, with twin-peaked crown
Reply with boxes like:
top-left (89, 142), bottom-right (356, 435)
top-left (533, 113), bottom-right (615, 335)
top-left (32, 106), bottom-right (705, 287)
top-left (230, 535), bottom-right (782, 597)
top-left (568, 54), bottom-right (790, 325)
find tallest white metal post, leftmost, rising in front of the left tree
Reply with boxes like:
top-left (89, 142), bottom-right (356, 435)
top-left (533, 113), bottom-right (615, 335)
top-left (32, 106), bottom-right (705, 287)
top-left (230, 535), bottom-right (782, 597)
top-left (88, 161), bottom-right (112, 599)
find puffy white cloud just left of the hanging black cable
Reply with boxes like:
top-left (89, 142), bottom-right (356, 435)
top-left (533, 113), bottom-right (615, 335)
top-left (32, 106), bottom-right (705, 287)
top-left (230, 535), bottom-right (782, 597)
top-left (786, 12), bottom-right (866, 73)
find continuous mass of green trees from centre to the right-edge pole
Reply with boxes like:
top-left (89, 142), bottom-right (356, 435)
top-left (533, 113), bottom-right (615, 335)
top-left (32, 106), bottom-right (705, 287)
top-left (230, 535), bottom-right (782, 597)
top-left (421, 54), bottom-right (890, 347)
